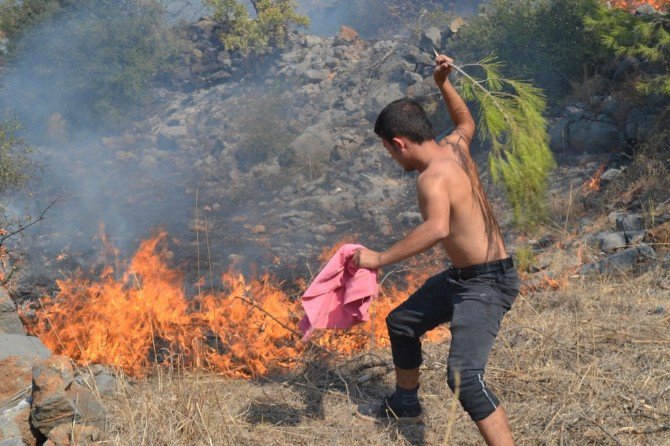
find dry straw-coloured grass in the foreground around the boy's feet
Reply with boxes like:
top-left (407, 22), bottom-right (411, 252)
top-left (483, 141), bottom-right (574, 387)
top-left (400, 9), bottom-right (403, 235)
top-left (106, 268), bottom-right (670, 446)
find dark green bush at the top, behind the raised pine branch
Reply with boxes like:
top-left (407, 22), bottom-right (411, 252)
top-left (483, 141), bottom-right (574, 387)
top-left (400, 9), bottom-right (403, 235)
top-left (448, 0), bottom-right (608, 100)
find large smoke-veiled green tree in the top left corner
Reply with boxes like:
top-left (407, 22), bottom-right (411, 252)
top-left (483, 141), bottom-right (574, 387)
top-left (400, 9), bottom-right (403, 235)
top-left (2, 0), bottom-right (183, 129)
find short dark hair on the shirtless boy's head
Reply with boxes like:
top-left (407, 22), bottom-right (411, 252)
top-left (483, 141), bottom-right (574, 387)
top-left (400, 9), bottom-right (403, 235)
top-left (375, 98), bottom-right (435, 144)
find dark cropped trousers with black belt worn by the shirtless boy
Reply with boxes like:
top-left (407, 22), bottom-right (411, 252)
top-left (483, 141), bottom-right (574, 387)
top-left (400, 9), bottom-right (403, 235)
top-left (386, 260), bottom-right (519, 419)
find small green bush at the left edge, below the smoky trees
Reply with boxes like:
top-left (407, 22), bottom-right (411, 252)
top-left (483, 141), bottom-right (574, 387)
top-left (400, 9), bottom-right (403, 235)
top-left (0, 120), bottom-right (31, 193)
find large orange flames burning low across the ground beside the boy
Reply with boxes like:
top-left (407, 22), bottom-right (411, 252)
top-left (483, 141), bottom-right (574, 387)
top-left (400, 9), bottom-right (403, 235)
top-left (22, 232), bottom-right (448, 377)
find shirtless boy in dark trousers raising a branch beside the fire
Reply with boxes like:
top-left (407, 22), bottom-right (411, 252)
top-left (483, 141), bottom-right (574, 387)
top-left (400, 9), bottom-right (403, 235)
top-left (354, 55), bottom-right (519, 446)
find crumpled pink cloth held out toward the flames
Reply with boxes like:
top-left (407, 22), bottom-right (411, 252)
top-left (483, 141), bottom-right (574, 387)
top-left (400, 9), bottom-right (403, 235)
top-left (298, 244), bottom-right (379, 341)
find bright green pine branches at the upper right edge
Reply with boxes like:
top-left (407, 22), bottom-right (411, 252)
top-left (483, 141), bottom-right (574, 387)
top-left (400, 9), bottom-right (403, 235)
top-left (585, 6), bottom-right (670, 96)
